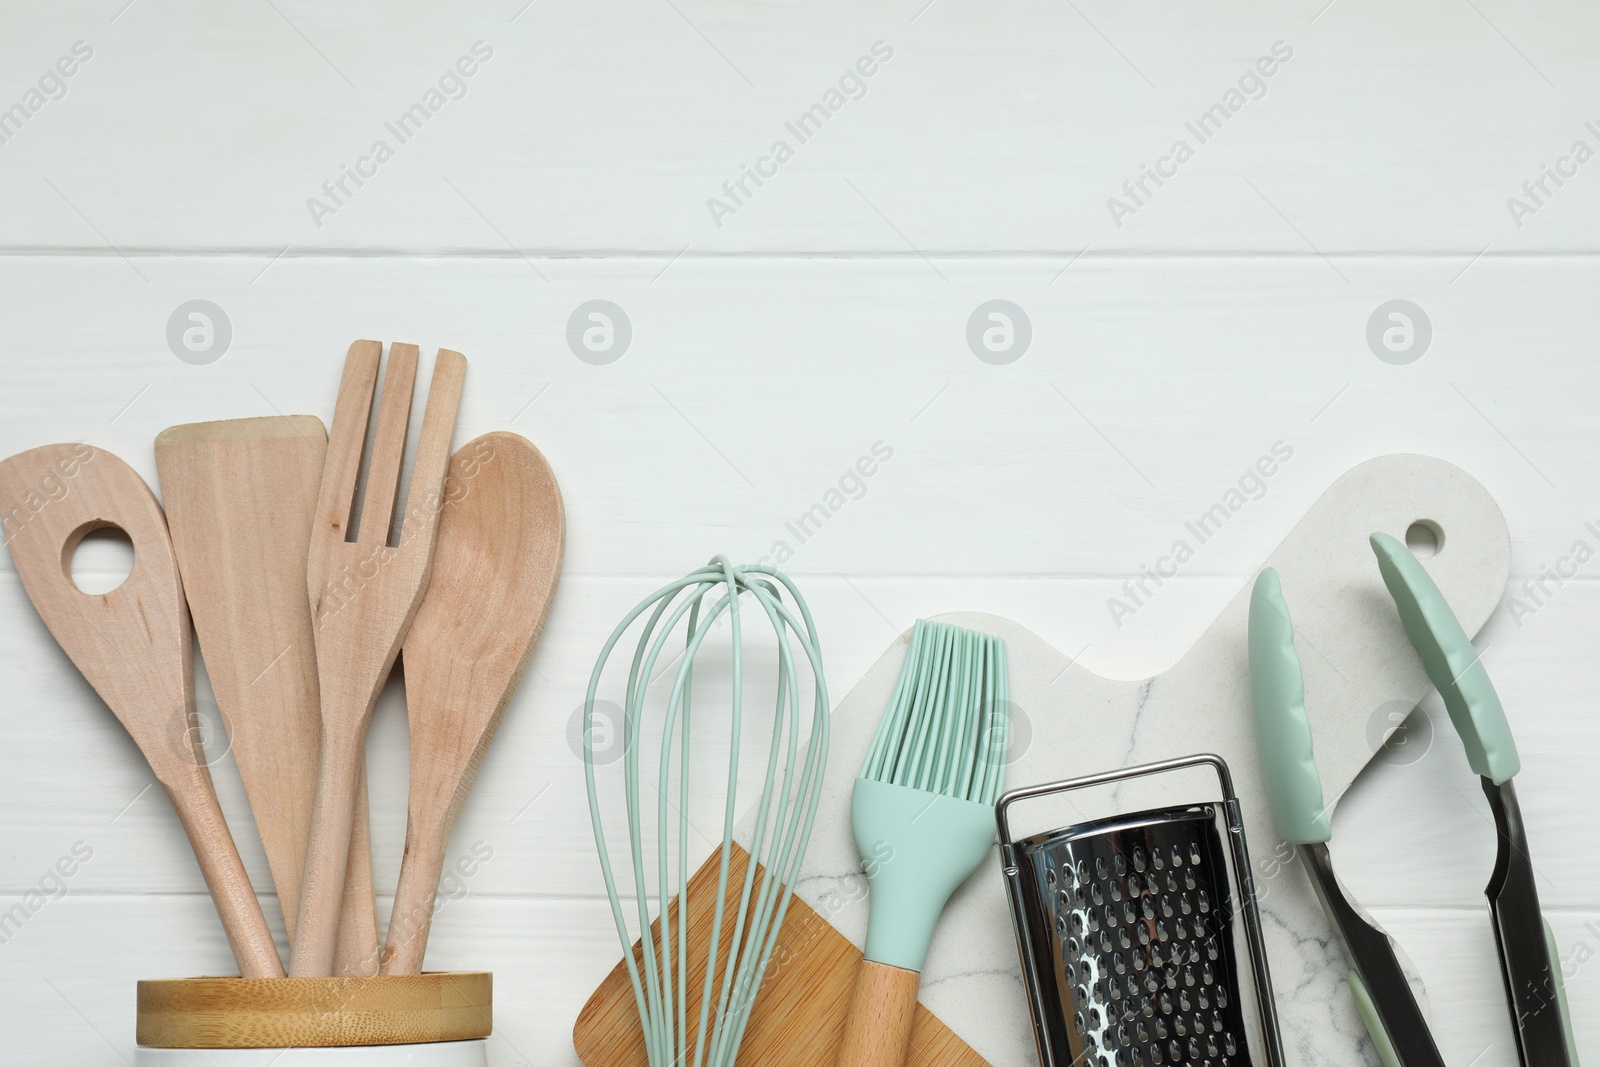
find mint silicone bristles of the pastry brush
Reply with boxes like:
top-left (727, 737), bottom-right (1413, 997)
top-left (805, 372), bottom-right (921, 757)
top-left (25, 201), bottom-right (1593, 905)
top-left (861, 619), bottom-right (1011, 805)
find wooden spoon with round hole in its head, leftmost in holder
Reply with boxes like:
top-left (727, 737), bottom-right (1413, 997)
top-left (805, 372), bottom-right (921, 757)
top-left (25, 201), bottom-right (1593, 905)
top-left (0, 445), bottom-right (283, 977)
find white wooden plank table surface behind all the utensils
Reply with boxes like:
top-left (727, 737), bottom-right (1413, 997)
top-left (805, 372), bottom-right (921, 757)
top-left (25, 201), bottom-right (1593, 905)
top-left (0, 0), bottom-right (1600, 1067)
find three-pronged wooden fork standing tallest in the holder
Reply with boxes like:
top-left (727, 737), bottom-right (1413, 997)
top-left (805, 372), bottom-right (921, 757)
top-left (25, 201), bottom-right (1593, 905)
top-left (290, 341), bottom-right (467, 977)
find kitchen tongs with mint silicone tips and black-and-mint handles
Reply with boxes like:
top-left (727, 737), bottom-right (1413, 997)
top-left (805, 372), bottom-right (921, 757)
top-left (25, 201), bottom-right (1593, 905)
top-left (1250, 533), bottom-right (1578, 1067)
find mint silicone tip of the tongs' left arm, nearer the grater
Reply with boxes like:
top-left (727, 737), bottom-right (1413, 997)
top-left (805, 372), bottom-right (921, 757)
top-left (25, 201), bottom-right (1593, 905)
top-left (1250, 566), bottom-right (1333, 845)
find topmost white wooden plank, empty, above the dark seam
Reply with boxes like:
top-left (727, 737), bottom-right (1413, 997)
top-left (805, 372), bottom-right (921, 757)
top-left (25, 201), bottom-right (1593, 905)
top-left (0, 0), bottom-right (1600, 254)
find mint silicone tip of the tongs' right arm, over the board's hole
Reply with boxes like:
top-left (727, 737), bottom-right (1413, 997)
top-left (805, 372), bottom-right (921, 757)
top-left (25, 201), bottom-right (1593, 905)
top-left (1371, 533), bottom-right (1522, 785)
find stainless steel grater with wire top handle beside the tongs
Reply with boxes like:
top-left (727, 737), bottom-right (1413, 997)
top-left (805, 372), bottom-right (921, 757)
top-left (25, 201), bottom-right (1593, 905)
top-left (995, 755), bottom-right (1283, 1067)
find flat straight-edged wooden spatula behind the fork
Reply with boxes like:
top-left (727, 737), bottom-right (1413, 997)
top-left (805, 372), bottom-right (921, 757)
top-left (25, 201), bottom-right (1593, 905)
top-left (155, 414), bottom-right (378, 974)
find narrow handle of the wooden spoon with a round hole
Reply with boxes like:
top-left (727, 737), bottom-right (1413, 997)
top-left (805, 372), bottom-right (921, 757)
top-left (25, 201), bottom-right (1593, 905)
top-left (162, 765), bottom-right (283, 977)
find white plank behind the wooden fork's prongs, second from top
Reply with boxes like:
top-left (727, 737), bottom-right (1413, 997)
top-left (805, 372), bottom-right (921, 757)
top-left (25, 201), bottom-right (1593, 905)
top-left (0, 256), bottom-right (1600, 585)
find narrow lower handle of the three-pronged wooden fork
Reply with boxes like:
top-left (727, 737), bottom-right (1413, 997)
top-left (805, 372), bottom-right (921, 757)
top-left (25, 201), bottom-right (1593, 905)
top-left (290, 735), bottom-right (362, 977)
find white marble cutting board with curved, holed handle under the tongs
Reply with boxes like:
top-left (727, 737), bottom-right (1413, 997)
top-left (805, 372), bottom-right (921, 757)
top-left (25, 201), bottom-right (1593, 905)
top-left (739, 456), bottom-right (1510, 1067)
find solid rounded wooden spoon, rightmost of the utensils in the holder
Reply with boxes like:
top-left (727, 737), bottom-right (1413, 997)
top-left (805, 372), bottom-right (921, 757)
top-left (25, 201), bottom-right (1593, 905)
top-left (384, 434), bottom-right (566, 974)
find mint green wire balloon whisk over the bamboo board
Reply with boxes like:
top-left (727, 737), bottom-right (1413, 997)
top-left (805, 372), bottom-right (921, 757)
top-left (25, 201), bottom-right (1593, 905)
top-left (584, 557), bottom-right (829, 1067)
